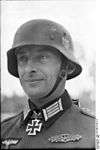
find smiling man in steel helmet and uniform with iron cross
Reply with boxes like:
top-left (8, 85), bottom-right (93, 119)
top-left (1, 19), bottom-right (95, 149)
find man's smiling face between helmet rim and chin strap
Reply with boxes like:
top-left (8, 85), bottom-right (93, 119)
top-left (17, 46), bottom-right (61, 103)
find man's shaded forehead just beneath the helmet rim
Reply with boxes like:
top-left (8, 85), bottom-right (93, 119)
top-left (15, 45), bottom-right (60, 55)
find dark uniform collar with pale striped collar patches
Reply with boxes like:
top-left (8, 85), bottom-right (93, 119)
top-left (23, 90), bottom-right (72, 127)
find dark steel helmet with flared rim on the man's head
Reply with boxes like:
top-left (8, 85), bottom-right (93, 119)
top-left (7, 19), bottom-right (82, 80)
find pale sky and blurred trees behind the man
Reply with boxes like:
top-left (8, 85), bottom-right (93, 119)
top-left (1, 0), bottom-right (96, 120)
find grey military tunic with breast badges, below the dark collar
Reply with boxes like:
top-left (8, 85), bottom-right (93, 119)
top-left (1, 92), bottom-right (95, 149)
